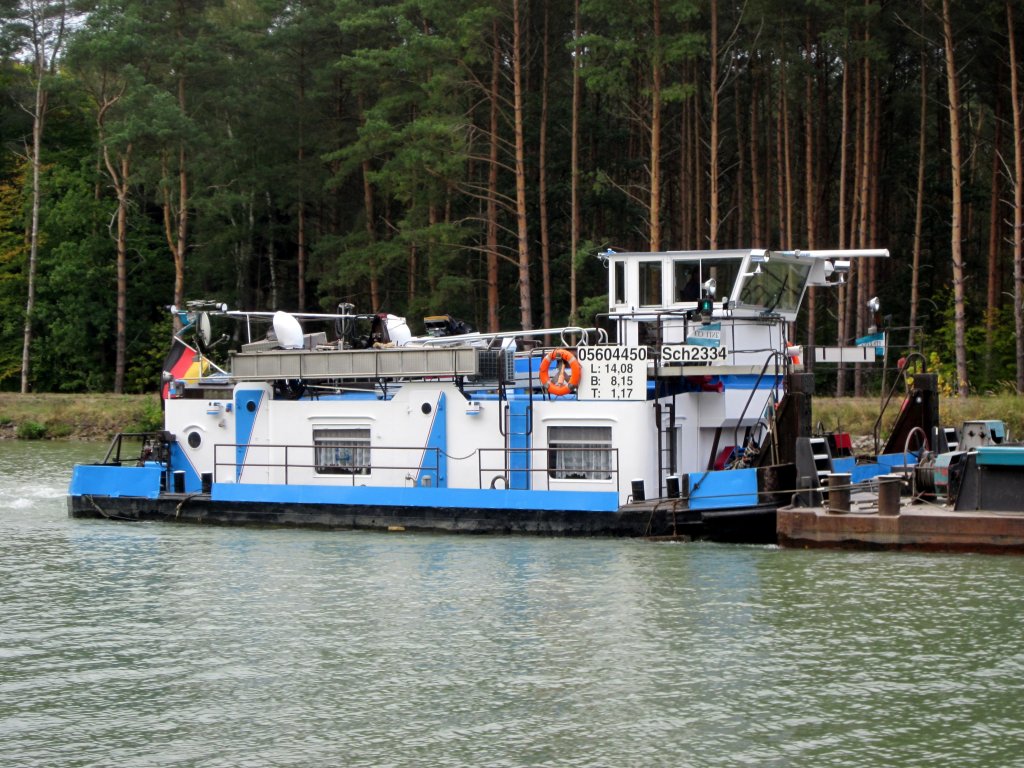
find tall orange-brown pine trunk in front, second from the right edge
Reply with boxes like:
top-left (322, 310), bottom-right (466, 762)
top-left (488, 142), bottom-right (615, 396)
top-left (942, 0), bottom-right (970, 398)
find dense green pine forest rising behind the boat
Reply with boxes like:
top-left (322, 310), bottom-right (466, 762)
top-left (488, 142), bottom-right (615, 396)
top-left (0, 0), bottom-right (1024, 403)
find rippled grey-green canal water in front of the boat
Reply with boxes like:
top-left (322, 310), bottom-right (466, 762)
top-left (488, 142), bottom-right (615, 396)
top-left (0, 442), bottom-right (1024, 768)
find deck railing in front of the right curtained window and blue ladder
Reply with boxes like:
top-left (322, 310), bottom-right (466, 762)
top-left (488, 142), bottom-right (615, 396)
top-left (476, 445), bottom-right (620, 493)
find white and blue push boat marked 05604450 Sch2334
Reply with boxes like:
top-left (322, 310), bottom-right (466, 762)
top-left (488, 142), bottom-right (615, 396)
top-left (68, 249), bottom-right (913, 543)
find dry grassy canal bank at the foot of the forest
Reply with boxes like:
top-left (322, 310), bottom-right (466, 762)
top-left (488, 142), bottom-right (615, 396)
top-left (0, 392), bottom-right (1024, 440)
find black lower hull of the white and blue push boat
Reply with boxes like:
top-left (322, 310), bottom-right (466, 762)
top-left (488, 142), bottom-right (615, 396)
top-left (68, 494), bottom-right (776, 544)
